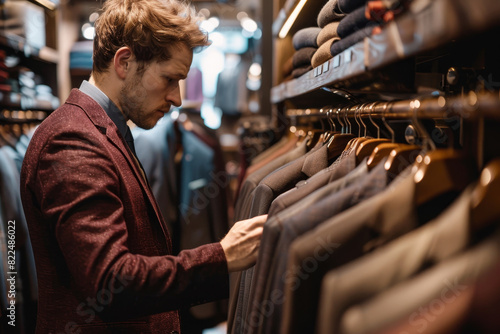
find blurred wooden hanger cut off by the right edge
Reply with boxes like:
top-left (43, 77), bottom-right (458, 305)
top-left (470, 158), bottom-right (500, 232)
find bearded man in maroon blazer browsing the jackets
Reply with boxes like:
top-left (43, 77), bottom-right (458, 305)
top-left (21, 0), bottom-right (266, 334)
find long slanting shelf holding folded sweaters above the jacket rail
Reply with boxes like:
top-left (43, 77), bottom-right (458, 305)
top-left (271, 0), bottom-right (500, 103)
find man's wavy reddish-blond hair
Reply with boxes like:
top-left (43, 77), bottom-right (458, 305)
top-left (92, 0), bottom-right (210, 73)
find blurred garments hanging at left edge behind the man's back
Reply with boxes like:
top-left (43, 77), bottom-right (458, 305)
top-left (0, 111), bottom-right (45, 334)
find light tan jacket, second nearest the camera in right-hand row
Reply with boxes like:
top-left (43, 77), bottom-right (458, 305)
top-left (317, 188), bottom-right (472, 334)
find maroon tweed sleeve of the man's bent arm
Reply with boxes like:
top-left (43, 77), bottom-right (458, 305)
top-left (32, 134), bottom-right (228, 317)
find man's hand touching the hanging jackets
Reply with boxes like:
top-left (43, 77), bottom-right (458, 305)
top-left (220, 215), bottom-right (267, 272)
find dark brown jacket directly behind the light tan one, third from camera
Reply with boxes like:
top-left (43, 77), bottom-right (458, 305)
top-left (281, 168), bottom-right (417, 333)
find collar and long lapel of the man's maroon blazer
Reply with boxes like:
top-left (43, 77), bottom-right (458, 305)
top-left (66, 89), bottom-right (172, 252)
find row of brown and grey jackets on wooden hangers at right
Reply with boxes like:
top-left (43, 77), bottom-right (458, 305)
top-left (228, 93), bottom-right (500, 334)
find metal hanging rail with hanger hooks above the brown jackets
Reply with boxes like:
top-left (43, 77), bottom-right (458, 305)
top-left (286, 92), bottom-right (500, 169)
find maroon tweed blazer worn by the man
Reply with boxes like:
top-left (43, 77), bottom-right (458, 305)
top-left (21, 89), bottom-right (229, 334)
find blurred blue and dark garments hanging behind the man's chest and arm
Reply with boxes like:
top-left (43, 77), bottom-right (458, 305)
top-left (132, 111), bottom-right (229, 334)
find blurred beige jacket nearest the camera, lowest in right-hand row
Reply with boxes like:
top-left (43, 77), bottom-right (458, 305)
top-left (340, 230), bottom-right (500, 334)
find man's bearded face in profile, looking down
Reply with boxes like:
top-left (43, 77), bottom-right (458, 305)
top-left (119, 44), bottom-right (193, 129)
